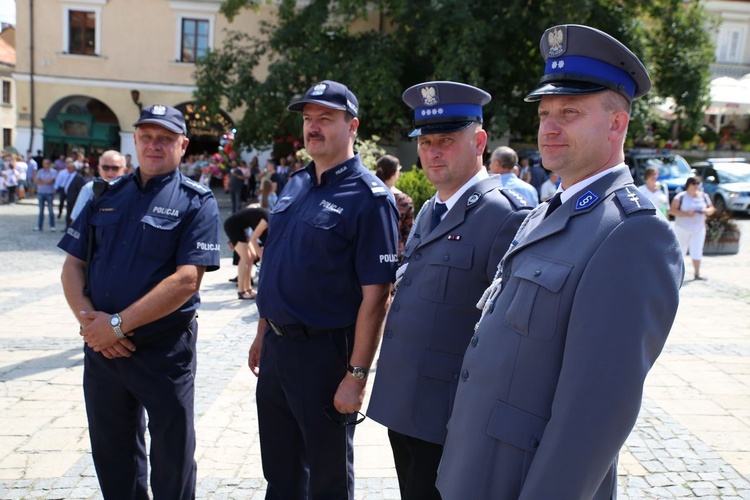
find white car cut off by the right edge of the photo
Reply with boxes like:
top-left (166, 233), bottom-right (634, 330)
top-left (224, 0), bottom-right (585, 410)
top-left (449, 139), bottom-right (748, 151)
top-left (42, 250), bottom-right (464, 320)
top-left (693, 158), bottom-right (750, 213)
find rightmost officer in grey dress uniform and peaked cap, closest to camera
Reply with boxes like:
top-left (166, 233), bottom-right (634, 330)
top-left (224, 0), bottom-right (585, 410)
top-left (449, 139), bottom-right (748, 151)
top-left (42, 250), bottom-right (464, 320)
top-left (437, 25), bottom-right (684, 499)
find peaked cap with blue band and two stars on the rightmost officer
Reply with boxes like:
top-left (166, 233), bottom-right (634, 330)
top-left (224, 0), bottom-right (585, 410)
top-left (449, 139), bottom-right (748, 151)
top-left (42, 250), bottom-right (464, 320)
top-left (525, 24), bottom-right (651, 102)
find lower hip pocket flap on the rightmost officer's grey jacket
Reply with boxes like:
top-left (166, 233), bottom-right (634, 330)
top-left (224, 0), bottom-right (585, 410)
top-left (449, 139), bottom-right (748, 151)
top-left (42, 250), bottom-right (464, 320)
top-left (487, 401), bottom-right (547, 453)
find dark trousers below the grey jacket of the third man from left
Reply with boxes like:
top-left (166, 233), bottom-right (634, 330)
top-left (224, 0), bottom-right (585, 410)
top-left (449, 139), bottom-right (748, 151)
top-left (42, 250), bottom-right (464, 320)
top-left (388, 429), bottom-right (443, 500)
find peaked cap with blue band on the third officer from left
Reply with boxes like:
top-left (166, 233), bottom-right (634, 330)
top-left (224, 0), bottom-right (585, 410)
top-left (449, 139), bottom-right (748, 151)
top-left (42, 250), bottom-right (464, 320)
top-left (401, 82), bottom-right (492, 137)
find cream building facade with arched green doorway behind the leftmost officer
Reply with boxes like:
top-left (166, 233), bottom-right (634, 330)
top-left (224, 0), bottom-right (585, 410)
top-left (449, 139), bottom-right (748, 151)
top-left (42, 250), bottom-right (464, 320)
top-left (13, 0), bottom-right (272, 162)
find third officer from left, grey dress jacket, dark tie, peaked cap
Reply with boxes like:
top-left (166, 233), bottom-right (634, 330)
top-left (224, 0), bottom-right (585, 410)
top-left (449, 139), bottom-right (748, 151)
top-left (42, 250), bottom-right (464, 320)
top-left (367, 82), bottom-right (529, 500)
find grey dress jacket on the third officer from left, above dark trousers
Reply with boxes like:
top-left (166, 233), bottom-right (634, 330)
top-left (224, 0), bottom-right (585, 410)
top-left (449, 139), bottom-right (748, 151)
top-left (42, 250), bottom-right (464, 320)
top-left (367, 177), bottom-right (529, 444)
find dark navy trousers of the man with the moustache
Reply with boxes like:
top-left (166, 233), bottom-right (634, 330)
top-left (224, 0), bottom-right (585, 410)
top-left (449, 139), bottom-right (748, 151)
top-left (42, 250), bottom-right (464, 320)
top-left (256, 329), bottom-right (354, 500)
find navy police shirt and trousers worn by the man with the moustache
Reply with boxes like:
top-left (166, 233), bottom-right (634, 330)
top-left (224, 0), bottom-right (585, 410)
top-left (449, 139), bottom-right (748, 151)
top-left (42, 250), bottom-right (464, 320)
top-left (257, 150), bottom-right (398, 499)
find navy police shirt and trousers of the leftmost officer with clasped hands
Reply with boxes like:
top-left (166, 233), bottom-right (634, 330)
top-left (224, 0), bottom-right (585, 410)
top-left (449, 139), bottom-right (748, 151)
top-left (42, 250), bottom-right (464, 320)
top-left (58, 153), bottom-right (220, 500)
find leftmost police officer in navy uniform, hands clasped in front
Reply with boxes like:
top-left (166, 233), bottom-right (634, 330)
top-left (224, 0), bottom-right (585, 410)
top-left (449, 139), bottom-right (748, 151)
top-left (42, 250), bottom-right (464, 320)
top-left (58, 105), bottom-right (221, 500)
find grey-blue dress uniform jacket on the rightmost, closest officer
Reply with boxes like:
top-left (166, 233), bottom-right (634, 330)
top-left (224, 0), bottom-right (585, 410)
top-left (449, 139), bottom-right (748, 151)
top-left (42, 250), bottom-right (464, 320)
top-left (437, 168), bottom-right (684, 500)
